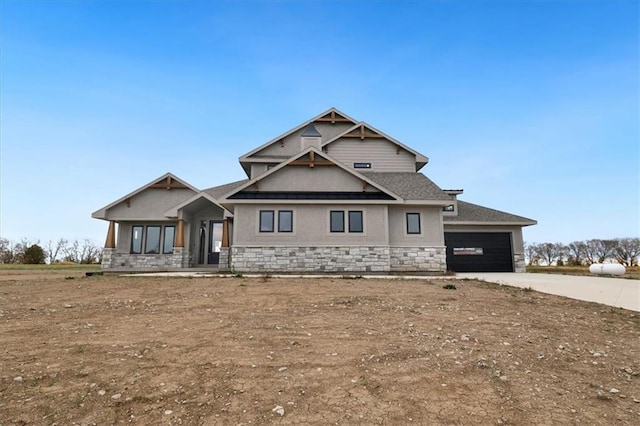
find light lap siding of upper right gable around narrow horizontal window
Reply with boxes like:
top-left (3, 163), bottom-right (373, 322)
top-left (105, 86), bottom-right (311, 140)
top-left (325, 138), bottom-right (416, 172)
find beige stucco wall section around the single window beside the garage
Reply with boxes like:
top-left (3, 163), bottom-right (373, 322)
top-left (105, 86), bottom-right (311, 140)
top-left (389, 206), bottom-right (444, 247)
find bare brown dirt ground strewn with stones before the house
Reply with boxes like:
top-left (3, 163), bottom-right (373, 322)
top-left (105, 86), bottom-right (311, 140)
top-left (0, 271), bottom-right (640, 425)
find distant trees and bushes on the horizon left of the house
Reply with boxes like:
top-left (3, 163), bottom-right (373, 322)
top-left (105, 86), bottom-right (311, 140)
top-left (0, 238), bottom-right (102, 265)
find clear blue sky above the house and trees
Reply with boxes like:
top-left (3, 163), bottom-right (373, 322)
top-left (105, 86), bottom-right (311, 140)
top-left (0, 0), bottom-right (640, 244)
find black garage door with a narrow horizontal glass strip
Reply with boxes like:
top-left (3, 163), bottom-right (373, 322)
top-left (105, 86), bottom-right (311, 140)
top-left (444, 232), bottom-right (513, 272)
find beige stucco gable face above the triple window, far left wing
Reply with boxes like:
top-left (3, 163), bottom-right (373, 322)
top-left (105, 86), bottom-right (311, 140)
top-left (106, 188), bottom-right (195, 220)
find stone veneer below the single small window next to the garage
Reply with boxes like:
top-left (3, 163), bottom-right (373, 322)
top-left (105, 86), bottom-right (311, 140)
top-left (390, 247), bottom-right (447, 272)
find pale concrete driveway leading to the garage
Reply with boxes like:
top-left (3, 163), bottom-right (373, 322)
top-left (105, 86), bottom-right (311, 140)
top-left (456, 272), bottom-right (640, 312)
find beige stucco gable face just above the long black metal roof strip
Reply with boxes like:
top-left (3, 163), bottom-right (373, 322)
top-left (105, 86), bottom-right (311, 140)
top-left (259, 166), bottom-right (379, 192)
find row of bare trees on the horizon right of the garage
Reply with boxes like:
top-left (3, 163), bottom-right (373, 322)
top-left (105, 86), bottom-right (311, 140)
top-left (524, 238), bottom-right (640, 266)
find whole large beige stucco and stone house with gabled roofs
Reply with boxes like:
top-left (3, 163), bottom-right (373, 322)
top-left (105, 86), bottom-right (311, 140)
top-left (92, 108), bottom-right (536, 273)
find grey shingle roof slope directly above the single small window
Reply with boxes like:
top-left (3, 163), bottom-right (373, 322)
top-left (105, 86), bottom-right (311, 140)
top-left (362, 172), bottom-right (453, 201)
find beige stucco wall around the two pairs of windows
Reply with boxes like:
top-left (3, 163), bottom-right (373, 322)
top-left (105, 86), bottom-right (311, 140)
top-left (233, 204), bottom-right (388, 247)
